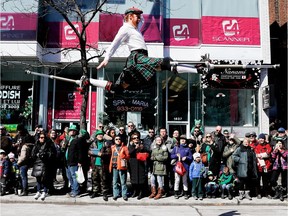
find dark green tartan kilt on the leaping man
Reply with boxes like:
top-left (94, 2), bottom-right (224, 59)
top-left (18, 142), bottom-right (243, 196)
top-left (116, 51), bottom-right (163, 89)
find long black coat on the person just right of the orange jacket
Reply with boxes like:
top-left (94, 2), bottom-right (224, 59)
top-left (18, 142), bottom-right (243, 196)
top-left (128, 144), bottom-right (149, 184)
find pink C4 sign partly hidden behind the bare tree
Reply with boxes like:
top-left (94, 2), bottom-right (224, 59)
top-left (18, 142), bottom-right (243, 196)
top-left (47, 22), bottom-right (99, 48)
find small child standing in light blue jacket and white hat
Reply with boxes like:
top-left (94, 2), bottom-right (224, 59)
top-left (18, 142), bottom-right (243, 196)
top-left (189, 153), bottom-right (205, 200)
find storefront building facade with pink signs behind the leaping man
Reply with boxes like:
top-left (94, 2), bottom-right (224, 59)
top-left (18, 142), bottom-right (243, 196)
top-left (1, 0), bottom-right (287, 137)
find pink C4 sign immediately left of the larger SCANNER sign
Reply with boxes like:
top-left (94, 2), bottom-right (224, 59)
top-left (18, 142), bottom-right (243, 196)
top-left (164, 19), bottom-right (200, 46)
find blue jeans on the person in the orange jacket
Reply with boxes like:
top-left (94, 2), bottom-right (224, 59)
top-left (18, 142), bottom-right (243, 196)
top-left (113, 168), bottom-right (127, 198)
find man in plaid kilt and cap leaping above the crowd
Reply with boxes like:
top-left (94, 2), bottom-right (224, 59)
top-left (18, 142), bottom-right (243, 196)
top-left (88, 7), bottom-right (203, 92)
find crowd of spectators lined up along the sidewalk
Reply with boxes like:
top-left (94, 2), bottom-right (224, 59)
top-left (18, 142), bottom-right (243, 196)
top-left (0, 122), bottom-right (288, 201)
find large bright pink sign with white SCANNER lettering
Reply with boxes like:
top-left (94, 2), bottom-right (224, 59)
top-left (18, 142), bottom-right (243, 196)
top-left (202, 16), bottom-right (260, 45)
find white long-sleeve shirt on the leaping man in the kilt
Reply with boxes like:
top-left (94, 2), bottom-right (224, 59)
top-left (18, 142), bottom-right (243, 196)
top-left (104, 23), bottom-right (147, 61)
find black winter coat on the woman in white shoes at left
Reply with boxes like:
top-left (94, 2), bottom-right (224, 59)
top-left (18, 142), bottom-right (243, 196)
top-left (31, 140), bottom-right (56, 179)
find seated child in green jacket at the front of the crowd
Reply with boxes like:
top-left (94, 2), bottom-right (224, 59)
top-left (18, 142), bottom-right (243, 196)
top-left (219, 167), bottom-right (234, 200)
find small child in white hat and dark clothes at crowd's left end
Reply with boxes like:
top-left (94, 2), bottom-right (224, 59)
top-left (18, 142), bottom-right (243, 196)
top-left (8, 152), bottom-right (22, 195)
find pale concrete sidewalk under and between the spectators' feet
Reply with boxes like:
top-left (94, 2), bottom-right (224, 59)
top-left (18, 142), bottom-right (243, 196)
top-left (0, 171), bottom-right (288, 206)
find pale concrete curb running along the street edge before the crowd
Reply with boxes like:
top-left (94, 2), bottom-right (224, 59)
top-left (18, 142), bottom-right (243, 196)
top-left (0, 195), bottom-right (288, 207)
